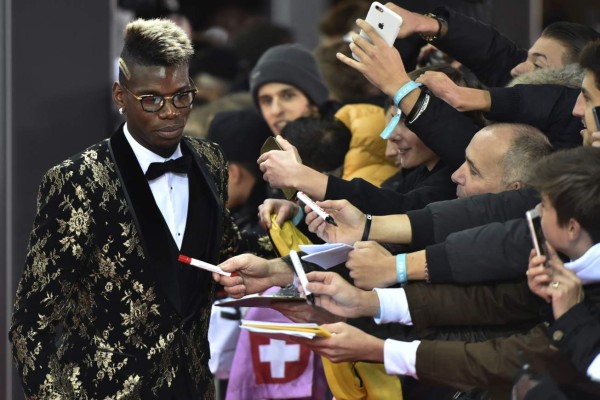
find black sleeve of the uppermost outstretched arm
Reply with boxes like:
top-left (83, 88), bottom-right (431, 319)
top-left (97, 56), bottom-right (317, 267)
top-left (433, 7), bottom-right (527, 87)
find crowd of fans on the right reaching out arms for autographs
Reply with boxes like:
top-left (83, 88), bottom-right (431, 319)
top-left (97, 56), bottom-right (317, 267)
top-left (203, 3), bottom-right (600, 399)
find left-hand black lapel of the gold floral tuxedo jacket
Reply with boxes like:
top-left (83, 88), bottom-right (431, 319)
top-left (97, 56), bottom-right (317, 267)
top-left (109, 127), bottom-right (183, 314)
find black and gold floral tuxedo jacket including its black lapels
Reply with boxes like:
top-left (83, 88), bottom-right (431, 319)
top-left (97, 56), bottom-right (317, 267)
top-left (9, 129), bottom-right (273, 399)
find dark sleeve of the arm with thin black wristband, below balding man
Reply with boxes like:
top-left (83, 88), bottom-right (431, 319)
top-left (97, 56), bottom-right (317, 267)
top-left (406, 188), bottom-right (540, 249)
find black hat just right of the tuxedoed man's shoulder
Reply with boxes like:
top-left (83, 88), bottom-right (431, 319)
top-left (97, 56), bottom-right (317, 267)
top-left (206, 108), bottom-right (271, 173)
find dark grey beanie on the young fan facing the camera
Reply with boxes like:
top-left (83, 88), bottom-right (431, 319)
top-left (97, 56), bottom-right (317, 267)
top-left (250, 44), bottom-right (329, 107)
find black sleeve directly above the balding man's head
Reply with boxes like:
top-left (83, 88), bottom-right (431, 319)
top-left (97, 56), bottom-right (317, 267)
top-left (486, 85), bottom-right (583, 149)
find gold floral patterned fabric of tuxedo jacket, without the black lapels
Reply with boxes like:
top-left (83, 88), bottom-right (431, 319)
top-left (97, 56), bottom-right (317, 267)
top-left (10, 137), bottom-right (233, 399)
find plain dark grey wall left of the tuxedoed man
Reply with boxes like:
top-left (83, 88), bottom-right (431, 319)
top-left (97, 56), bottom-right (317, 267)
top-left (0, 0), bottom-right (112, 399)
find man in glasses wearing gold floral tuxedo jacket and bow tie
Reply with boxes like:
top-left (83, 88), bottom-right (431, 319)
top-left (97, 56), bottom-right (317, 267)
top-left (9, 20), bottom-right (272, 399)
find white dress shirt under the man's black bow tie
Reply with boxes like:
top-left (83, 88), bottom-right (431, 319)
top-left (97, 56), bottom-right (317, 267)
top-left (123, 123), bottom-right (190, 249)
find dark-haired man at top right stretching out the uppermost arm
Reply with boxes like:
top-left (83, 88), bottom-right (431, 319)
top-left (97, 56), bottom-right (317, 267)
top-left (387, 3), bottom-right (600, 87)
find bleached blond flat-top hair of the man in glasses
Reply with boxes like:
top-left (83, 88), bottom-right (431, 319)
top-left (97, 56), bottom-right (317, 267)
top-left (119, 19), bottom-right (194, 80)
